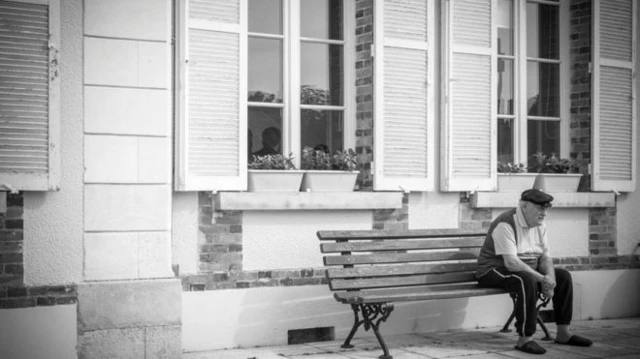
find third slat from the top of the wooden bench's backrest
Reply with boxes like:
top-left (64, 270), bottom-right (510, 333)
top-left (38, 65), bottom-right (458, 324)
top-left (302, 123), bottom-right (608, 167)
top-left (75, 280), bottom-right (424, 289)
top-left (323, 251), bottom-right (478, 266)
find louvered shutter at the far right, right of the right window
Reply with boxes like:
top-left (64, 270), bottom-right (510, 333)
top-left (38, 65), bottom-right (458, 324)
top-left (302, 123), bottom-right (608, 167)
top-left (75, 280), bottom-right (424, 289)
top-left (592, 0), bottom-right (637, 192)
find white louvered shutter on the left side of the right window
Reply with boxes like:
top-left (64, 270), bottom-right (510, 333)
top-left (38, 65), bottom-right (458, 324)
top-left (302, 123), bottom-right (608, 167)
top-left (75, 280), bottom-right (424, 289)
top-left (440, 0), bottom-right (497, 191)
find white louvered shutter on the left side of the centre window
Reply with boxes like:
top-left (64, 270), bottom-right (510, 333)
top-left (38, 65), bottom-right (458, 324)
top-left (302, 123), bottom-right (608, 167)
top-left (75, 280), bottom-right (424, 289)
top-left (176, 0), bottom-right (247, 191)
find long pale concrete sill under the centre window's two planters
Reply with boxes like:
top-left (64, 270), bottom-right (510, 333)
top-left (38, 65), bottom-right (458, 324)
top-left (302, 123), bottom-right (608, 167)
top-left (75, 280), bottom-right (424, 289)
top-left (215, 192), bottom-right (402, 211)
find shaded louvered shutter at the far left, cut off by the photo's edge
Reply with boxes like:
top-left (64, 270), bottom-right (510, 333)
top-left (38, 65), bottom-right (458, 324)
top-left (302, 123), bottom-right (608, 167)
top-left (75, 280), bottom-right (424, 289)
top-left (0, 0), bottom-right (60, 191)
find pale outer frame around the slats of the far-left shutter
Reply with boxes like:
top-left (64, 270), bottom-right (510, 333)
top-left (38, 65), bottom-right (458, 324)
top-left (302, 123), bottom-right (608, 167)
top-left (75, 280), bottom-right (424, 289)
top-left (0, 0), bottom-right (61, 192)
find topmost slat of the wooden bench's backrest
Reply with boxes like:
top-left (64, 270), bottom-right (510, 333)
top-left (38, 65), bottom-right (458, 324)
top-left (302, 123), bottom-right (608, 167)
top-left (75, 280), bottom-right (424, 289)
top-left (316, 228), bottom-right (487, 241)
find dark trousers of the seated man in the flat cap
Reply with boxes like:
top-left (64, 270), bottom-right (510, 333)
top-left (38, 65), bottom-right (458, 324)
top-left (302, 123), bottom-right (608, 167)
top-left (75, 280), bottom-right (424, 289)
top-left (478, 268), bottom-right (573, 337)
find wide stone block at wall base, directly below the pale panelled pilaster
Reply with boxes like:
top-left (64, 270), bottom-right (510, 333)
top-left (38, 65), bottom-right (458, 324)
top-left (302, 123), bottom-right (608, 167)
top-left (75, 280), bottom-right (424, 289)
top-left (78, 279), bottom-right (182, 331)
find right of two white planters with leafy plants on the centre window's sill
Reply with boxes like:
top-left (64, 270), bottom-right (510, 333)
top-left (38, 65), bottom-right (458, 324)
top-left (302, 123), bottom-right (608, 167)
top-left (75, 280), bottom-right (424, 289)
top-left (300, 146), bottom-right (359, 192)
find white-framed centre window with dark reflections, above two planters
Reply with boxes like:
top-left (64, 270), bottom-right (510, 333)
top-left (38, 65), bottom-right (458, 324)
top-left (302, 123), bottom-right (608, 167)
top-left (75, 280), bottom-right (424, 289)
top-left (247, 0), bottom-right (353, 166)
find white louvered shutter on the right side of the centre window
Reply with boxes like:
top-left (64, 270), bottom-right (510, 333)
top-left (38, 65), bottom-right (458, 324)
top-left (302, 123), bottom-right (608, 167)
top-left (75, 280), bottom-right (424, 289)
top-left (374, 0), bottom-right (435, 191)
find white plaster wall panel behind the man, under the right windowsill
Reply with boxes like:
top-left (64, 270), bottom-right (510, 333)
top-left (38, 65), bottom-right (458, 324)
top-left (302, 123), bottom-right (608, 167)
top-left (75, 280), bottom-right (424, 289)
top-left (492, 208), bottom-right (589, 258)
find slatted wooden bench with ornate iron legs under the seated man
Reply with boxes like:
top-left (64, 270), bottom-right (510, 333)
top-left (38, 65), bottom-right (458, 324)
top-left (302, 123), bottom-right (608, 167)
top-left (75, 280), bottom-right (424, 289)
top-left (317, 229), bottom-right (550, 359)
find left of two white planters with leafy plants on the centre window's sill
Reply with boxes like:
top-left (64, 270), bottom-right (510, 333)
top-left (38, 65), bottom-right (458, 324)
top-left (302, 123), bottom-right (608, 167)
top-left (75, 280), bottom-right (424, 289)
top-left (248, 154), bottom-right (304, 192)
